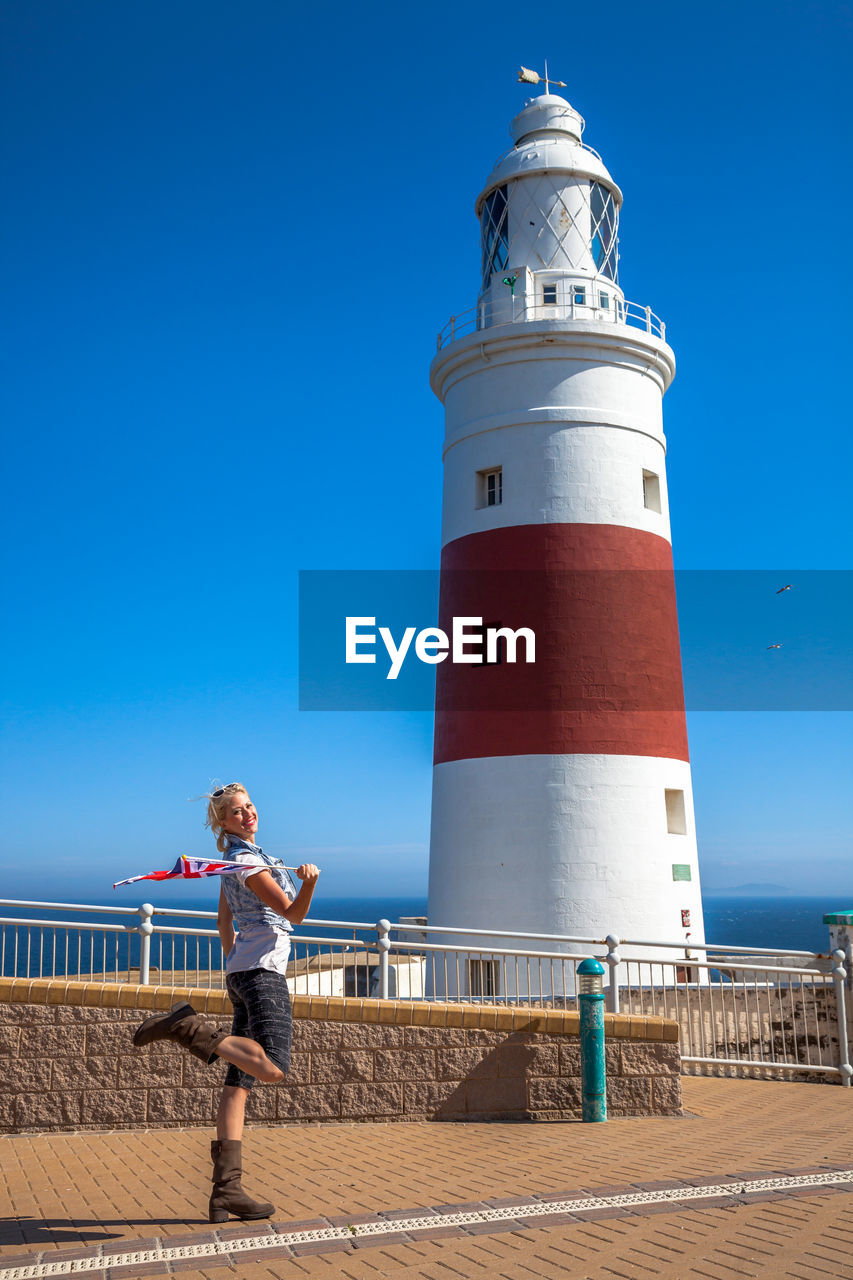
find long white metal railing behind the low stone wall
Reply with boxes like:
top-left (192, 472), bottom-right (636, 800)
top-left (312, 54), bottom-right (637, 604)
top-left (0, 899), bottom-right (853, 1085)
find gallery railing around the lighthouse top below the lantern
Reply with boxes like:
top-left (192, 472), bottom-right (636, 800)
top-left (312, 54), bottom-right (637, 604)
top-left (435, 293), bottom-right (666, 351)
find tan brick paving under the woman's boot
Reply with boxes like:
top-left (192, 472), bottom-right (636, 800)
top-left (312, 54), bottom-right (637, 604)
top-left (0, 1076), bottom-right (853, 1280)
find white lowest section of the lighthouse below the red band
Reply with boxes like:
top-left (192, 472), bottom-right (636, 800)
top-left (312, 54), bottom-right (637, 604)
top-left (429, 755), bottom-right (704, 954)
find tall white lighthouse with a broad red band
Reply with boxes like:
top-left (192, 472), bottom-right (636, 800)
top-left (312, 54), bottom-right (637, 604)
top-left (429, 85), bottom-right (703, 995)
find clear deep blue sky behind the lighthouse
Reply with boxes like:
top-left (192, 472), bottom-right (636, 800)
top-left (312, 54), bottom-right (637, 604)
top-left (0, 0), bottom-right (853, 906)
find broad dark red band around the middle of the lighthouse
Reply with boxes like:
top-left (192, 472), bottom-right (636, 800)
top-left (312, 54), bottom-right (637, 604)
top-left (434, 524), bottom-right (688, 764)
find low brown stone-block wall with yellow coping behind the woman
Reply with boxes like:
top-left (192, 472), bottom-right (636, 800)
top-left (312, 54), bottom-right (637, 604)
top-left (0, 979), bottom-right (681, 1133)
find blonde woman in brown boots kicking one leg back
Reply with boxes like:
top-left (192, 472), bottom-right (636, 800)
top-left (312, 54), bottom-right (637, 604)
top-left (133, 782), bottom-right (320, 1222)
